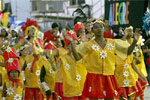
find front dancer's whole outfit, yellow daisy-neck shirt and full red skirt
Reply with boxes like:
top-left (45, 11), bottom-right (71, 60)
top-left (77, 39), bottom-right (128, 99)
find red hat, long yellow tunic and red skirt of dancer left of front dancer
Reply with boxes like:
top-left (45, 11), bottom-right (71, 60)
top-left (55, 32), bottom-right (87, 100)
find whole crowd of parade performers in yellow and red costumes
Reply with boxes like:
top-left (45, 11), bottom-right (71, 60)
top-left (0, 19), bottom-right (150, 100)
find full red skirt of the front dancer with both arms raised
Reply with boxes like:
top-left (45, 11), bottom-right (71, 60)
top-left (82, 73), bottom-right (120, 99)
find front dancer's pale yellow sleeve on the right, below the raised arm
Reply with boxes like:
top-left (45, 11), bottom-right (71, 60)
top-left (115, 39), bottom-right (130, 60)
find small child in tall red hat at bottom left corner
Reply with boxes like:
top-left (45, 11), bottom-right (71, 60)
top-left (2, 58), bottom-right (23, 100)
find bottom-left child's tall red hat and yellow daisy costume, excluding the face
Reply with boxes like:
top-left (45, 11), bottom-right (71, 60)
top-left (5, 58), bottom-right (23, 100)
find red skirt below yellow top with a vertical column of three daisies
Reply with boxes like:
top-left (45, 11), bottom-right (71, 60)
top-left (121, 86), bottom-right (138, 100)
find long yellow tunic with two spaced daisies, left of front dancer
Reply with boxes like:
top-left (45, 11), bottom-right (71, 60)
top-left (61, 55), bottom-right (87, 97)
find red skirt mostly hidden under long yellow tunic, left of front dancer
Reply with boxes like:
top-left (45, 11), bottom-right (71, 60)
top-left (55, 82), bottom-right (87, 100)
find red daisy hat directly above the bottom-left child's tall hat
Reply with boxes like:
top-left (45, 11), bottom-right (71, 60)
top-left (3, 47), bottom-right (19, 60)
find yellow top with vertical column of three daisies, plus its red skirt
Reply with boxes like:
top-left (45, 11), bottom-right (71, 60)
top-left (115, 54), bottom-right (138, 100)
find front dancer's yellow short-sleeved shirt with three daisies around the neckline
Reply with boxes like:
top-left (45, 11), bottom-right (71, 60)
top-left (77, 39), bottom-right (129, 75)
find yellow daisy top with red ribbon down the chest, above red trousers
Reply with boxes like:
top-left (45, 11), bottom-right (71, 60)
top-left (25, 55), bottom-right (47, 88)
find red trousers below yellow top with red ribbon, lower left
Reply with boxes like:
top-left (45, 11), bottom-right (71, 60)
top-left (24, 88), bottom-right (44, 100)
